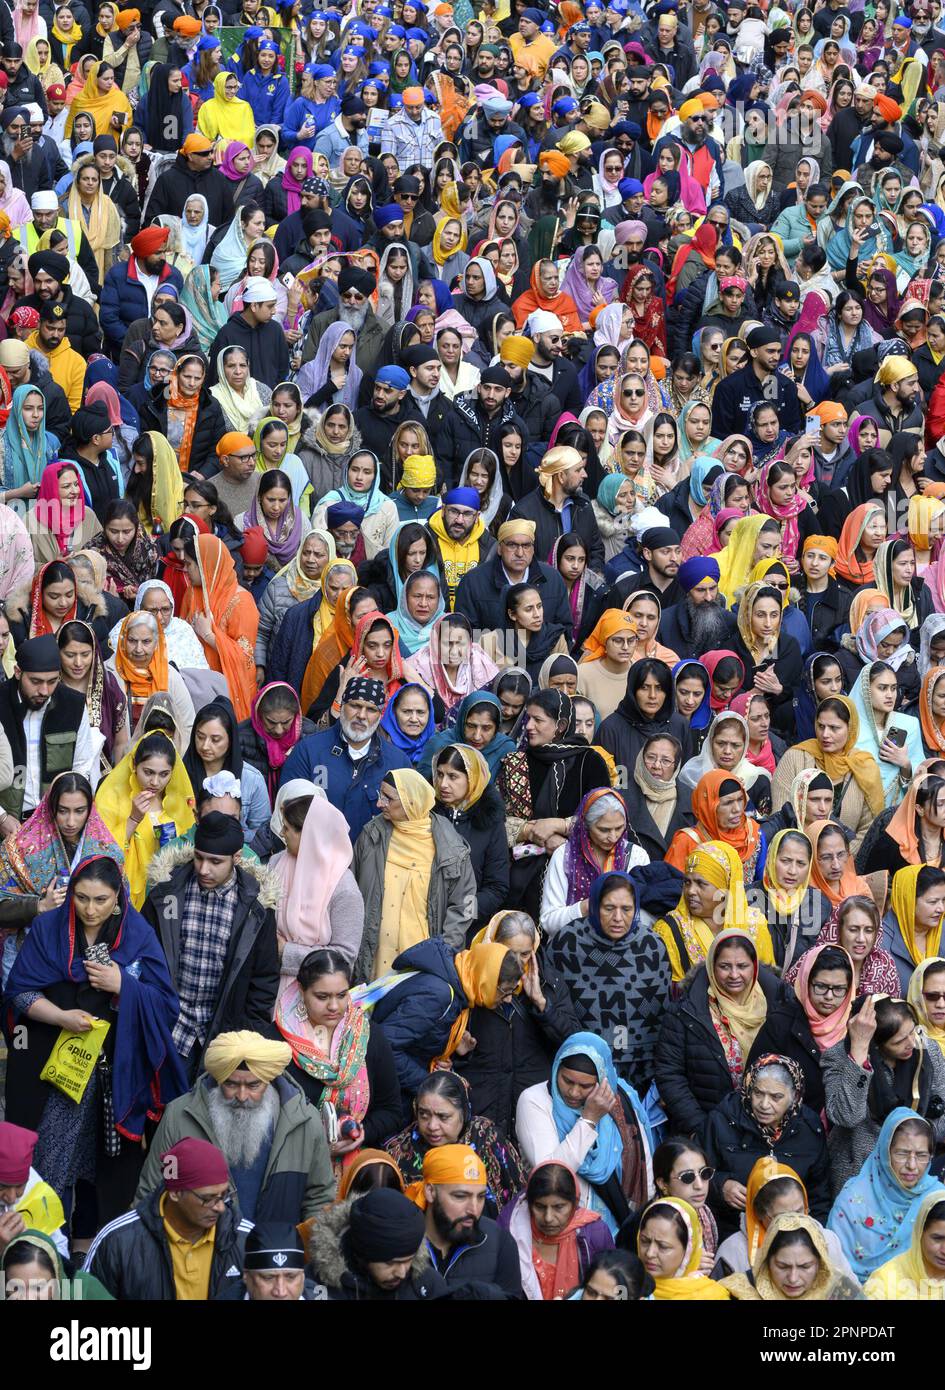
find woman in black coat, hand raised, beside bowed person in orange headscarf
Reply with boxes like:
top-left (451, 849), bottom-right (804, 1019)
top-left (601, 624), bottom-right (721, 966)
top-left (453, 912), bottom-right (581, 1138)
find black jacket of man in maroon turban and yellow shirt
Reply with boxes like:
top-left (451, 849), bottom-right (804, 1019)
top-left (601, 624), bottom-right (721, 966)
top-left (85, 1188), bottom-right (253, 1302)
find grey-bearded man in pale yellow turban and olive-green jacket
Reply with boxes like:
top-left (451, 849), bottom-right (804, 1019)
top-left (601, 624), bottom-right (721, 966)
top-left (135, 1030), bottom-right (335, 1226)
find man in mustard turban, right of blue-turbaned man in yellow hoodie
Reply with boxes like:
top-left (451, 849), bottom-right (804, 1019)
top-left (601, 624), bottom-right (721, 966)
top-left (456, 517), bottom-right (574, 631)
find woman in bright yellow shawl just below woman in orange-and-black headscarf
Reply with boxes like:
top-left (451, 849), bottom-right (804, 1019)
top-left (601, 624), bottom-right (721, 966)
top-left (653, 840), bottom-right (774, 984)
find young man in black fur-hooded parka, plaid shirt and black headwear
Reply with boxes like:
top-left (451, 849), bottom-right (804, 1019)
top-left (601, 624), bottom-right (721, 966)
top-left (142, 810), bottom-right (279, 1076)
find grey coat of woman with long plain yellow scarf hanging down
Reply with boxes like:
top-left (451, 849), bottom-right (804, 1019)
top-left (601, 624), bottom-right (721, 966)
top-left (352, 816), bottom-right (477, 980)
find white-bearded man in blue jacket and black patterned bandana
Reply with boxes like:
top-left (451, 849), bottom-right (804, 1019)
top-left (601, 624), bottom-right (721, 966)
top-left (273, 676), bottom-right (410, 844)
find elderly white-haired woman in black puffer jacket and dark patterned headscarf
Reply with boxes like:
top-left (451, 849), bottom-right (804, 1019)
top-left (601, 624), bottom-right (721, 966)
top-left (703, 1052), bottom-right (831, 1236)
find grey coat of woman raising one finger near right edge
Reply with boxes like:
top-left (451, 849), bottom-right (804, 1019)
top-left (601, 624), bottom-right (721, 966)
top-left (820, 1038), bottom-right (945, 1197)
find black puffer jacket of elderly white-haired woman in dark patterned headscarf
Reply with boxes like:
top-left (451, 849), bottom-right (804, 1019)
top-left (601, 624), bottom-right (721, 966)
top-left (703, 1091), bottom-right (831, 1236)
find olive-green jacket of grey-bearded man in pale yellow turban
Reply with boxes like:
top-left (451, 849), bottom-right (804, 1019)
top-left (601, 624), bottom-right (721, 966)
top-left (135, 1073), bottom-right (335, 1225)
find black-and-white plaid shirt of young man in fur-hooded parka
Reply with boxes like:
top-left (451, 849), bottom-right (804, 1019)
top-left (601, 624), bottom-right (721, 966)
top-left (174, 874), bottom-right (239, 1056)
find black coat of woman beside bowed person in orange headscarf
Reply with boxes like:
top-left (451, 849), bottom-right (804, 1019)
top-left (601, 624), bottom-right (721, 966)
top-left (453, 962), bottom-right (581, 1138)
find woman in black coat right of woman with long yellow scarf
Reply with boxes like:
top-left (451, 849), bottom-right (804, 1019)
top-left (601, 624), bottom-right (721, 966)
top-left (432, 744), bottom-right (509, 935)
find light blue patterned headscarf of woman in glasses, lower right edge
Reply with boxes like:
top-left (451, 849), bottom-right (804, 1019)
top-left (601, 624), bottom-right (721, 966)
top-left (827, 1105), bottom-right (945, 1283)
